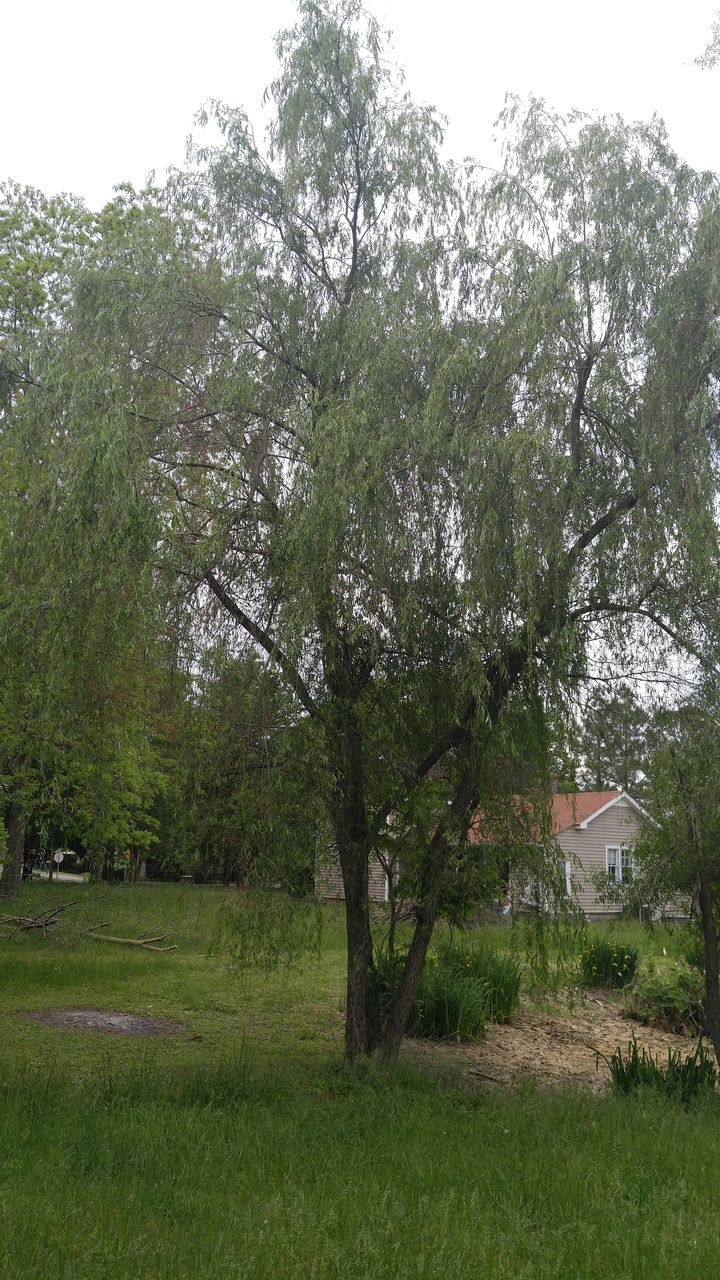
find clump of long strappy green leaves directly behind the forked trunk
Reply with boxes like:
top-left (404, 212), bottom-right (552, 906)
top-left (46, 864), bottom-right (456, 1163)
top-left (377, 942), bottom-right (520, 1041)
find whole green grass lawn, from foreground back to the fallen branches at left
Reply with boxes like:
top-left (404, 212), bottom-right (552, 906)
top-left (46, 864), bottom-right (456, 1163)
top-left (0, 884), bottom-right (720, 1280)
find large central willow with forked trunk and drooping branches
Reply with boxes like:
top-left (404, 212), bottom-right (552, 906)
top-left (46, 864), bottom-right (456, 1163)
top-left (57, 0), bottom-right (717, 1057)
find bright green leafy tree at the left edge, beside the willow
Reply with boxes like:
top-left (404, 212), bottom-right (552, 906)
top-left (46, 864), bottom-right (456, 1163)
top-left (0, 183), bottom-right (169, 896)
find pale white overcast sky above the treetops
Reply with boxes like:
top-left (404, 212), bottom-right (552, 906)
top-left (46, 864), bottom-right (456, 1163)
top-left (0, 0), bottom-right (720, 206)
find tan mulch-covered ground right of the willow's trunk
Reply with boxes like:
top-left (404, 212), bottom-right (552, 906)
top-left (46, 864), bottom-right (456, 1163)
top-left (409, 998), bottom-right (693, 1093)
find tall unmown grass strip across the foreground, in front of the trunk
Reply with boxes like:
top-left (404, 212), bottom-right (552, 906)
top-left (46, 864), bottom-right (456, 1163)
top-left (0, 1049), bottom-right (720, 1280)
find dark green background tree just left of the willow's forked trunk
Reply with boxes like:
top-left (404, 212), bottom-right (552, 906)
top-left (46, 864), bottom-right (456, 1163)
top-left (176, 644), bottom-right (323, 891)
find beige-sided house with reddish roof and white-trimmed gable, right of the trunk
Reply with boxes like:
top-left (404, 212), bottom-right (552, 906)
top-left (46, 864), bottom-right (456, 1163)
top-left (469, 788), bottom-right (648, 919)
